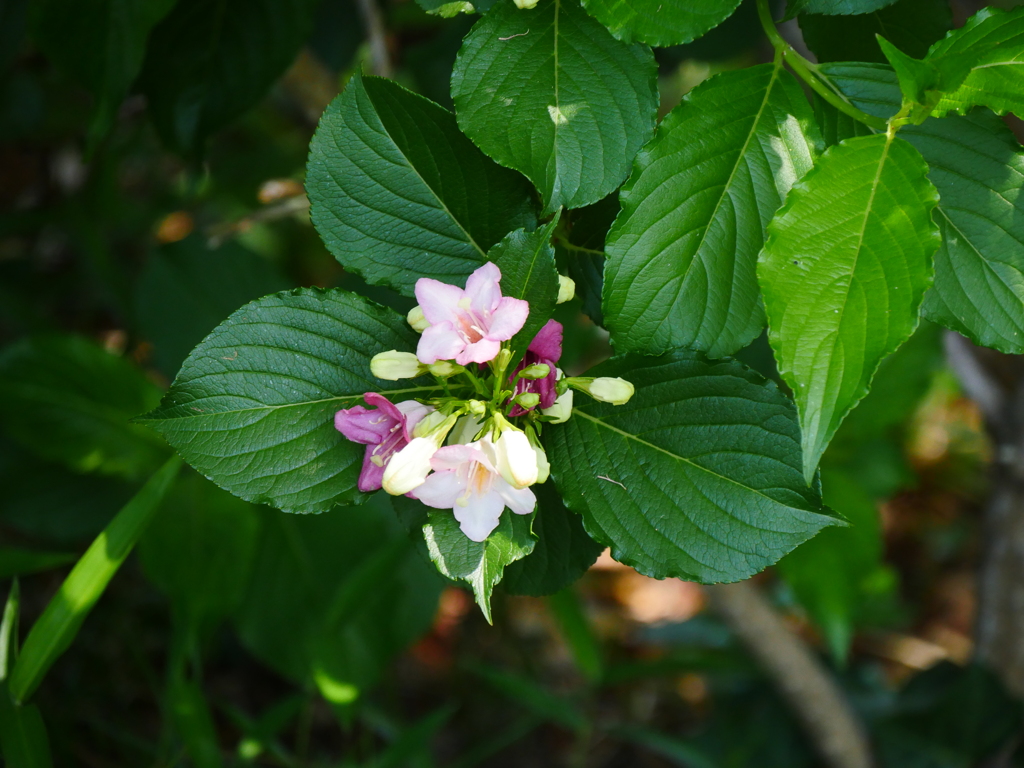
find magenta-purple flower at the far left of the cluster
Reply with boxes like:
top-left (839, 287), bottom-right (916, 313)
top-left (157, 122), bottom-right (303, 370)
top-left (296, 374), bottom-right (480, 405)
top-left (334, 392), bottom-right (433, 492)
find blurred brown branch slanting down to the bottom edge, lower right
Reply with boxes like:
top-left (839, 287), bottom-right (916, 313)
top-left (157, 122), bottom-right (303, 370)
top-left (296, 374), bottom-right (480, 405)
top-left (708, 582), bottom-right (874, 768)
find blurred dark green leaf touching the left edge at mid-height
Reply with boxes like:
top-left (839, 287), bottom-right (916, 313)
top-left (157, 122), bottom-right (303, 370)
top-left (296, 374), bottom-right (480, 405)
top-left (0, 335), bottom-right (166, 478)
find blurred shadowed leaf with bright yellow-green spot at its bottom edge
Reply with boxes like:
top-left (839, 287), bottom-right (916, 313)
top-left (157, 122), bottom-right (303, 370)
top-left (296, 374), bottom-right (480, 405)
top-left (236, 494), bottom-right (441, 700)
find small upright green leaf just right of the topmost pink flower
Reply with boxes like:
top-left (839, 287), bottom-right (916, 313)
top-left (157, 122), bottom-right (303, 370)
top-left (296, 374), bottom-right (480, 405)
top-left (487, 215), bottom-right (558, 366)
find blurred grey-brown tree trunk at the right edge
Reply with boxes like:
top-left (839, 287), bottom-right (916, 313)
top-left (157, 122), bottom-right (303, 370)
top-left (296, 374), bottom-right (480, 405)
top-left (946, 332), bottom-right (1024, 696)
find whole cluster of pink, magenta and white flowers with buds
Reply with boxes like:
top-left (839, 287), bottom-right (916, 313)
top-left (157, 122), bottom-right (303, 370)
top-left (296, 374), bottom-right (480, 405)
top-left (334, 263), bottom-right (633, 542)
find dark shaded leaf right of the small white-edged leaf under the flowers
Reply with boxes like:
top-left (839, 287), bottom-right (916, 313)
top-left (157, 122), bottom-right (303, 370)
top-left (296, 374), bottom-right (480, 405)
top-left (502, 481), bottom-right (604, 597)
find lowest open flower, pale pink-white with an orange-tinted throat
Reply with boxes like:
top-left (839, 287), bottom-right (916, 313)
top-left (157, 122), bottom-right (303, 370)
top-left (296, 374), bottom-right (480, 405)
top-left (412, 438), bottom-right (537, 542)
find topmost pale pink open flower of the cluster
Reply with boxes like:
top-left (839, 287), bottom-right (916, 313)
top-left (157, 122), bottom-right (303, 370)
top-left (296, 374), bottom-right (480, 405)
top-left (416, 262), bottom-right (529, 366)
